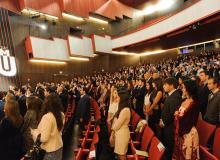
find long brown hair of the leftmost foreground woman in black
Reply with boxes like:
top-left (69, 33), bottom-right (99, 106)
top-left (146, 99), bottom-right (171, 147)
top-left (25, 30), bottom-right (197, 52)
top-left (4, 100), bottom-right (23, 128)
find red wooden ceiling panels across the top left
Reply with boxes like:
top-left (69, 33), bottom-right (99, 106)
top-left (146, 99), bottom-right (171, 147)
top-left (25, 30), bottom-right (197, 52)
top-left (0, 0), bottom-right (149, 18)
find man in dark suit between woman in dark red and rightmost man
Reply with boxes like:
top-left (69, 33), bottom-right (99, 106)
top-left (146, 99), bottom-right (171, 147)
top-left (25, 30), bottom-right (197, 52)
top-left (198, 71), bottom-right (210, 118)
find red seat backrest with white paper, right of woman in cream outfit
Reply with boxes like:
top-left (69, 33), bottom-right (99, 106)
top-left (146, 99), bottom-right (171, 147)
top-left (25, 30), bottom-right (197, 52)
top-left (148, 137), bottom-right (165, 160)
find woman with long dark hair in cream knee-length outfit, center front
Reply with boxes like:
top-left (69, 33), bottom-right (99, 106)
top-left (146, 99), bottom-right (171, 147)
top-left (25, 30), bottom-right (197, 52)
top-left (110, 93), bottom-right (131, 160)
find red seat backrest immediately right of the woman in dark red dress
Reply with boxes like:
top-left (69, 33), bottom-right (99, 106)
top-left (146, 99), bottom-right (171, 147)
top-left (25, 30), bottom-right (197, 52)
top-left (196, 119), bottom-right (216, 146)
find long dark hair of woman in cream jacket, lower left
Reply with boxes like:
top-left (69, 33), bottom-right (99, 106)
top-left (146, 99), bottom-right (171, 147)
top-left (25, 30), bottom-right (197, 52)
top-left (43, 93), bottom-right (63, 131)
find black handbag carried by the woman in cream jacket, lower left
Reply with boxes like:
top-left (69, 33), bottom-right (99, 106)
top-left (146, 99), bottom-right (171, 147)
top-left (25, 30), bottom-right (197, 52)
top-left (24, 134), bottom-right (46, 160)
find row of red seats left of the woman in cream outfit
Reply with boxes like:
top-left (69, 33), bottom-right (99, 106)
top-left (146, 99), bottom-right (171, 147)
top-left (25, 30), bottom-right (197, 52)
top-left (74, 98), bottom-right (101, 160)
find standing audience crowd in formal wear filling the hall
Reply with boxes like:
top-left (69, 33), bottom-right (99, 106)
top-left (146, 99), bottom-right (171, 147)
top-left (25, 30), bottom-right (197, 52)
top-left (0, 51), bottom-right (220, 160)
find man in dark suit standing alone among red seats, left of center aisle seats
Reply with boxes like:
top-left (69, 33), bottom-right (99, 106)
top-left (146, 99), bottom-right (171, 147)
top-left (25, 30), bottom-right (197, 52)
top-left (76, 87), bottom-right (90, 129)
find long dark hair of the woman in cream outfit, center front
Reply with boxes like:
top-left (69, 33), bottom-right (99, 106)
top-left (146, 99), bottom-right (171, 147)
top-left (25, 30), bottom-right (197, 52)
top-left (115, 91), bottom-right (130, 118)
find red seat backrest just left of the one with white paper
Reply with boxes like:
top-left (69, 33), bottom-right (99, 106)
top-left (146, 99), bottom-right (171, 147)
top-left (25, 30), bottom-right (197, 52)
top-left (140, 126), bottom-right (154, 151)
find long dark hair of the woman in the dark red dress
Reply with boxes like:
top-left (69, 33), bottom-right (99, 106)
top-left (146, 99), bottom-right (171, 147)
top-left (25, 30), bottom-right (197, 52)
top-left (183, 79), bottom-right (198, 100)
